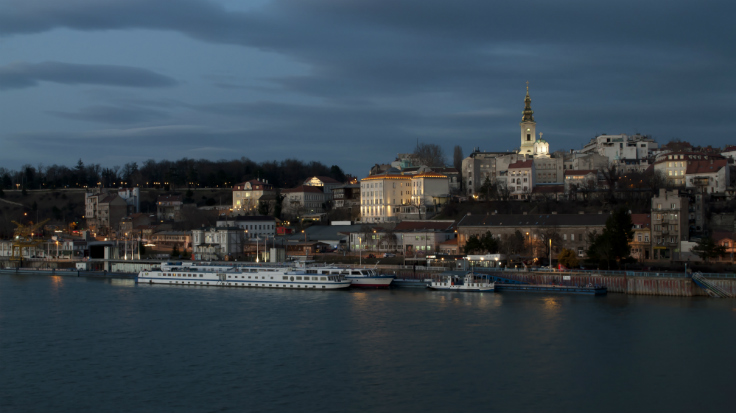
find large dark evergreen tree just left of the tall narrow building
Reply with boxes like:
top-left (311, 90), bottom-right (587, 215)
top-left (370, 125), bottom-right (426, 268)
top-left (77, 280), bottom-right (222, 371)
top-left (588, 207), bottom-right (634, 269)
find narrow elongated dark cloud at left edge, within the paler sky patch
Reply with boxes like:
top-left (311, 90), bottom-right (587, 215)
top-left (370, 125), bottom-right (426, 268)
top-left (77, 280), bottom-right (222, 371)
top-left (0, 62), bottom-right (177, 89)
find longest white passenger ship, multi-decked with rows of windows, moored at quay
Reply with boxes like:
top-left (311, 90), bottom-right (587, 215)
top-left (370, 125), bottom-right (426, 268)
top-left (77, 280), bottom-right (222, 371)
top-left (138, 263), bottom-right (351, 289)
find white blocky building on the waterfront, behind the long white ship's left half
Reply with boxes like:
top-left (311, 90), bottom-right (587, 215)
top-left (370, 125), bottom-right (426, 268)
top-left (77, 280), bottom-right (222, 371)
top-left (192, 226), bottom-right (245, 260)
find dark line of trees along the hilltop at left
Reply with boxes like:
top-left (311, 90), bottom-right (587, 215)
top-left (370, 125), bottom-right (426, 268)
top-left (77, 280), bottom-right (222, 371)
top-left (0, 158), bottom-right (347, 189)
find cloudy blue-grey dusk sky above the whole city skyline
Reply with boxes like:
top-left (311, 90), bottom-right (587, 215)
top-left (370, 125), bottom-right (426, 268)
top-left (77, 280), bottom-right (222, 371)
top-left (0, 0), bottom-right (736, 177)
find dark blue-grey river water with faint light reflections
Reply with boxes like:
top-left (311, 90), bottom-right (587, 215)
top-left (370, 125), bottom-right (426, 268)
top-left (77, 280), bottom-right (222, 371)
top-left (0, 275), bottom-right (736, 413)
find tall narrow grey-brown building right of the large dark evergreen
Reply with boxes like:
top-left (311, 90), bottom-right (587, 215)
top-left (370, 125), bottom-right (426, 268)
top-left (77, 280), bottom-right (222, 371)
top-left (651, 188), bottom-right (689, 260)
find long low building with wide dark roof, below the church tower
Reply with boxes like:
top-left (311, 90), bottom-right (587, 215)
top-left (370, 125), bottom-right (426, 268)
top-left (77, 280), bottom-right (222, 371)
top-left (457, 214), bottom-right (610, 258)
